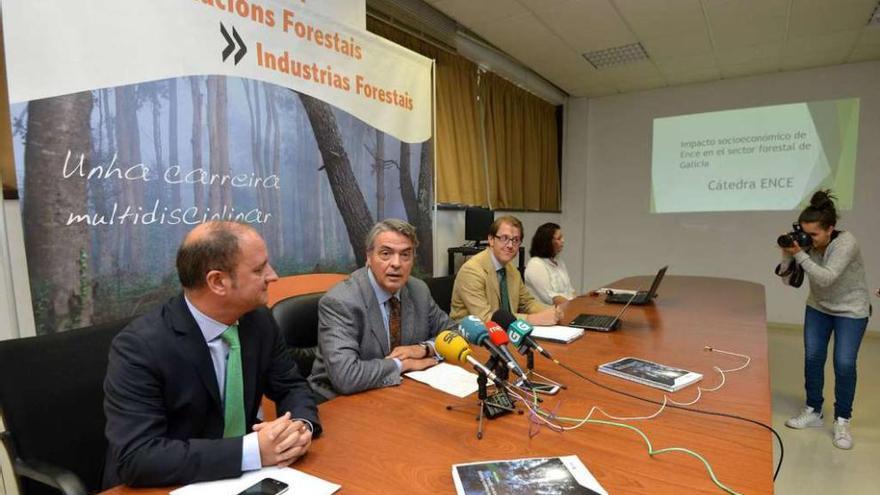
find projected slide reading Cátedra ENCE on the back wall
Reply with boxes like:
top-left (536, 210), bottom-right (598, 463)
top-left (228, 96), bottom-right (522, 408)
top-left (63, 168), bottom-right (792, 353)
top-left (651, 98), bottom-right (859, 213)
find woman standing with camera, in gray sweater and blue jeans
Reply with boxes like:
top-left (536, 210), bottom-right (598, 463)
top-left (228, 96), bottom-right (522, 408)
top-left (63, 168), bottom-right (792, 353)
top-left (777, 190), bottom-right (870, 449)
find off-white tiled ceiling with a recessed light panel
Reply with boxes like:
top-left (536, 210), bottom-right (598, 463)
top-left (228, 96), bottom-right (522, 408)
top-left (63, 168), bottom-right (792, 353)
top-left (426, 0), bottom-right (880, 97)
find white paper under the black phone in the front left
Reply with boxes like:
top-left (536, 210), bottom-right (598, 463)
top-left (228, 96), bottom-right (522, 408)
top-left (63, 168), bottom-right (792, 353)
top-left (171, 467), bottom-right (341, 495)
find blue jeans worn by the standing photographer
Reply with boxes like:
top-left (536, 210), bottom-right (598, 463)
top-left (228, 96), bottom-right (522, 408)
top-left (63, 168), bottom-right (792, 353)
top-left (804, 306), bottom-right (868, 419)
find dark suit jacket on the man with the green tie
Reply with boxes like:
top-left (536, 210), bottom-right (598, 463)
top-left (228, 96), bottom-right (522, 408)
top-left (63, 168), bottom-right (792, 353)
top-left (104, 295), bottom-right (321, 488)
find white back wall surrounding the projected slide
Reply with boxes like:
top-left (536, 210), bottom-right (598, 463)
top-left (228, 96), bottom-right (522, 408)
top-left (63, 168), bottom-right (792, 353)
top-left (562, 62), bottom-right (880, 329)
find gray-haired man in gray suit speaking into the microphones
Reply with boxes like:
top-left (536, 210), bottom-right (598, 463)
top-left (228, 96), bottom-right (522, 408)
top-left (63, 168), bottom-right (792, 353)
top-left (309, 219), bottom-right (454, 400)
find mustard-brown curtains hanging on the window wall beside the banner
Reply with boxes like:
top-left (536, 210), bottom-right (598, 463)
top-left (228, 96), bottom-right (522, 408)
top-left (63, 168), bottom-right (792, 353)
top-left (367, 17), bottom-right (559, 211)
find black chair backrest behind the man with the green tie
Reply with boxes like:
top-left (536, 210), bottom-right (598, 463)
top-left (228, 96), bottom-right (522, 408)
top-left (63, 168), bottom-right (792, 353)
top-left (0, 319), bottom-right (130, 495)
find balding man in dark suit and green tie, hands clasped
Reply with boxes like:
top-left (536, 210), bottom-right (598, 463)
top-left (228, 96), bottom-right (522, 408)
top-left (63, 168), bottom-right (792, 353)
top-left (104, 222), bottom-right (321, 487)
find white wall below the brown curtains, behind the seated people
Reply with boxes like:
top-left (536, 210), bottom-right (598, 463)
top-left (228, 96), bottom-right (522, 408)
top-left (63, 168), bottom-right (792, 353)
top-left (434, 210), bottom-right (564, 282)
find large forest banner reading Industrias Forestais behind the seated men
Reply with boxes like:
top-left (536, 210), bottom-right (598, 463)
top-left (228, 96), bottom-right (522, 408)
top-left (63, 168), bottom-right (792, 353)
top-left (3, 0), bottom-right (434, 333)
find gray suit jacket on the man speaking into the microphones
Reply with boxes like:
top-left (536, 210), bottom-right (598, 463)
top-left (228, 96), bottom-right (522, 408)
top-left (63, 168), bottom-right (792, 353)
top-left (309, 267), bottom-right (454, 400)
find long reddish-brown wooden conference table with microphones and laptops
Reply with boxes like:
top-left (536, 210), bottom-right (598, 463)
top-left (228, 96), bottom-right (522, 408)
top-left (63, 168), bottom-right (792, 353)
top-left (106, 276), bottom-right (773, 495)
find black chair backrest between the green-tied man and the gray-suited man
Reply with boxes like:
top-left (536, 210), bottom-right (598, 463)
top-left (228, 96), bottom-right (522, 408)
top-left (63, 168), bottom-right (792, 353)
top-left (272, 292), bottom-right (324, 376)
